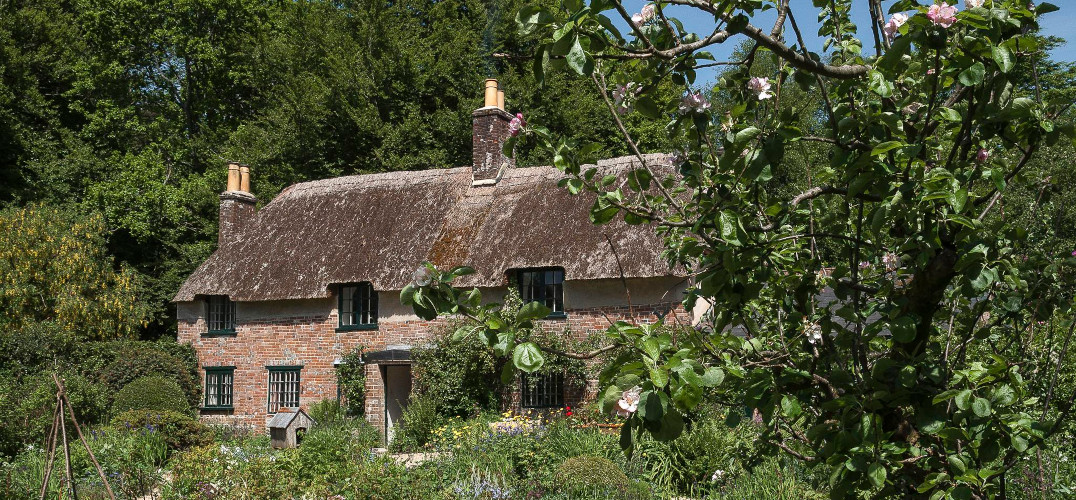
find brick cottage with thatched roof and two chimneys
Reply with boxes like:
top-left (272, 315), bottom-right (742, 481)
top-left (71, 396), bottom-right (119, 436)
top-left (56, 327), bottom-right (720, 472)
top-left (174, 81), bottom-right (691, 435)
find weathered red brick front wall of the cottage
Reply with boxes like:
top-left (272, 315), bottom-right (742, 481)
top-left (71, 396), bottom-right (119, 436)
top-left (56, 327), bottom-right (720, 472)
top-left (172, 298), bottom-right (691, 430)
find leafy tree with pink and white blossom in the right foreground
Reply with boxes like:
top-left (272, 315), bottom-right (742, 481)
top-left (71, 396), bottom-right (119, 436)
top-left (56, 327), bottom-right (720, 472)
top-left (411, 0), bottom-right (1076, 498)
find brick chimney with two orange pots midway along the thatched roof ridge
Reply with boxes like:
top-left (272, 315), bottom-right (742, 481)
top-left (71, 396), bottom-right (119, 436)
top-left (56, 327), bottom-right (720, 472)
top-left (471, 78), bottom-right (515, 186)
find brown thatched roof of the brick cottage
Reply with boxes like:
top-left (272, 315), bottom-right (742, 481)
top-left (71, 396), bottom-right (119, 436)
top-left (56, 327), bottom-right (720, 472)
top-left (174, 155), bottom-right (674, 302)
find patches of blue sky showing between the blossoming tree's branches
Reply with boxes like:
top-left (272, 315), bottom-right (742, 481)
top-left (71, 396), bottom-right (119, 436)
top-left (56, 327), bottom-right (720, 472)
top-left (607, 0), bottom-right (1076, 85)
